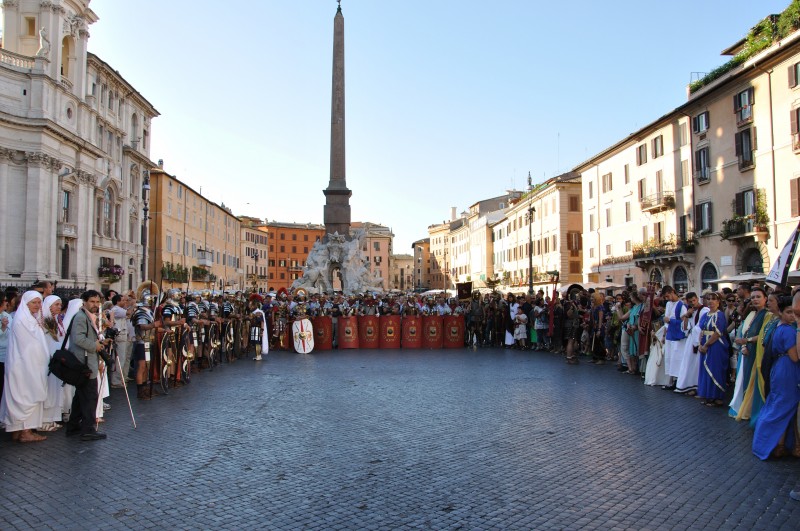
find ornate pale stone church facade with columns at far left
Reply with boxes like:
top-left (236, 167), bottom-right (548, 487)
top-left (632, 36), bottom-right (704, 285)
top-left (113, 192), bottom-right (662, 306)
top-left (0, 0), bottom-right (159, 290)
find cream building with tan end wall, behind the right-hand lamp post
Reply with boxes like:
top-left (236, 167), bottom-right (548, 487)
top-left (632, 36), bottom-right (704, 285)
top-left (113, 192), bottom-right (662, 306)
top-left (491, 173), bottom-right (582, 292)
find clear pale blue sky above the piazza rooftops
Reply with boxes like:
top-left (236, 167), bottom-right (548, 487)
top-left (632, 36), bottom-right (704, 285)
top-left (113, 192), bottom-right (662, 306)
top-left (89, 0), bottom-right (789, 253)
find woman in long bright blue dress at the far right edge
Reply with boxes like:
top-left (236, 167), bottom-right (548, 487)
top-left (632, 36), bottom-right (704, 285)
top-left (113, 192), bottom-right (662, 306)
top-left (753, 296), bottom-right (800, 460)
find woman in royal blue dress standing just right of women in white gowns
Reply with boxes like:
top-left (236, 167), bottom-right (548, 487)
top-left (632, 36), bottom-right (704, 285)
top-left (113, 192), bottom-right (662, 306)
top-left (697, 293), bottom-right (730, 406)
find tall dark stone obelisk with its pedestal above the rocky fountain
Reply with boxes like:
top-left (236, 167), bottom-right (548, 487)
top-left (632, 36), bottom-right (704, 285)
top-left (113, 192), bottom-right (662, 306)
top-left (323, 0), bottom-right (352, 238)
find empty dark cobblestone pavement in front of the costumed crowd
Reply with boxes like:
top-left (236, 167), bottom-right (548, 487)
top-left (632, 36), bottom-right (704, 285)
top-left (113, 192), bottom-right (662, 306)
top-left (0, 349), bottom-right (800, 530)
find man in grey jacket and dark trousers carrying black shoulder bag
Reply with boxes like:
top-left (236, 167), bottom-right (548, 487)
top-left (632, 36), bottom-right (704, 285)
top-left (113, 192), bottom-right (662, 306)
top-left (66, 290), bottom-right (112, 441)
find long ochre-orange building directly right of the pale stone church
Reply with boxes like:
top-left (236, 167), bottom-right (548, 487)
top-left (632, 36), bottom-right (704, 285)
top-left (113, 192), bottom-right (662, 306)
top-left (147, 164), bottom-right (245, 291)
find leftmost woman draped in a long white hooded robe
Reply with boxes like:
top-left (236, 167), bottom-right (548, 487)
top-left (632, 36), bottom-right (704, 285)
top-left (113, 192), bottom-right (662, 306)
top-left (0, 291), bottom-right (50, 442)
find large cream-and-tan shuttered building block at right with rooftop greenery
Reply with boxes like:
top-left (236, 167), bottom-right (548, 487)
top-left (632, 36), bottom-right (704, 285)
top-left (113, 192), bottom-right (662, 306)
top-left (575, 12), bottom-right (800, 291)
